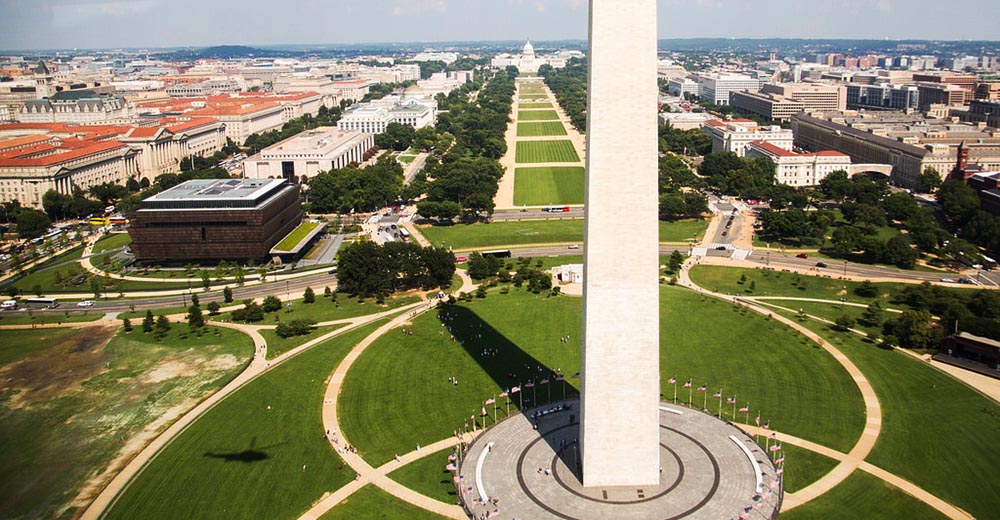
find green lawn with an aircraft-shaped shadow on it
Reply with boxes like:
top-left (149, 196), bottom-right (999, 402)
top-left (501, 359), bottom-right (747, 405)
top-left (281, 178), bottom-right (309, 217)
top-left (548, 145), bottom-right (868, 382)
top-left (107, 325), bottom-right (378, 520)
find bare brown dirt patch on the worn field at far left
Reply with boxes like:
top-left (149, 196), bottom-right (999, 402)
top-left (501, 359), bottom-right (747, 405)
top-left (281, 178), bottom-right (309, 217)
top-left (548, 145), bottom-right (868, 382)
top-left (0, 323), bottom-right (118, 408)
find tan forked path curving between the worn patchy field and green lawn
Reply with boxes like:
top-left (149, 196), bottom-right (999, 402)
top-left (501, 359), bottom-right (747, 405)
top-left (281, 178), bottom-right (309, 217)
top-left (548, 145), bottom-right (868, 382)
top-left (80, 302), bottom-right (423, 520)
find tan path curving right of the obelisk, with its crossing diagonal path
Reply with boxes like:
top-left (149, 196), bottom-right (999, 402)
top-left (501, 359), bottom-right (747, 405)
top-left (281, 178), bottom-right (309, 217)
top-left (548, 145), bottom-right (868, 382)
top-left (678, 259), bottom-right (972, 520)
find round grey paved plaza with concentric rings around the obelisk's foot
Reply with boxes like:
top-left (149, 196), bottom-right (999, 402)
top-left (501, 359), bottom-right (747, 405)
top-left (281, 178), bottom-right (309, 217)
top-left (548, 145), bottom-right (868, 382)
top-left (457, 401), bottom-right (781, 520)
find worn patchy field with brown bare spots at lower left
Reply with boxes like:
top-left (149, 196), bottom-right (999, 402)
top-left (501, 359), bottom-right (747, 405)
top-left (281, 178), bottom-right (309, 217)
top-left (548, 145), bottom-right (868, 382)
top-left (0, 324), bottom-right (253, 518)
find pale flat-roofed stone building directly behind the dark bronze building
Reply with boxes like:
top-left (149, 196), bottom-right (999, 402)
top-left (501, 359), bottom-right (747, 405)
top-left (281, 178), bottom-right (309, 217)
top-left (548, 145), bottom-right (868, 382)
top-left (243, 126), bottom-right (375, 182)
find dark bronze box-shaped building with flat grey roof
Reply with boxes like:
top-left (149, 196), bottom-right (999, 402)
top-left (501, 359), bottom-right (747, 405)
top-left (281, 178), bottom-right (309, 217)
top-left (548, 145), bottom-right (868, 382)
top-left (129, 179), bottom-right (302, 262)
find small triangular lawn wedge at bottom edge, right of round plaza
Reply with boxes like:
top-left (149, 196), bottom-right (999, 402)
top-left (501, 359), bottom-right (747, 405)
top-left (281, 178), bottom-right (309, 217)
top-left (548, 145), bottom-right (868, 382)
top-left (779, 470), bottom-right (944, 520)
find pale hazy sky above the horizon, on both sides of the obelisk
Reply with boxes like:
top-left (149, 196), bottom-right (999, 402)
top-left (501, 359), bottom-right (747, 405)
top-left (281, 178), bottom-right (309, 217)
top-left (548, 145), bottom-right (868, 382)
top-left (0, 0), bottom-right (1000, 50)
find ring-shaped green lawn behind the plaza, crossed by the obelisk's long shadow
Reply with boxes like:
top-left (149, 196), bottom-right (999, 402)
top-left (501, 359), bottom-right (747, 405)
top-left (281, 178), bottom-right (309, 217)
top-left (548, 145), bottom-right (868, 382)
top-left (339, 287), bottom-right (864, 465)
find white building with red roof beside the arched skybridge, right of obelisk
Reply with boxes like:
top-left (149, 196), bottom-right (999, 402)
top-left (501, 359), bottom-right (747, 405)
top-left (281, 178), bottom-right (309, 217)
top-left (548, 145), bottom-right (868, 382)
top-left (746, 141), bottom-right (851, 186)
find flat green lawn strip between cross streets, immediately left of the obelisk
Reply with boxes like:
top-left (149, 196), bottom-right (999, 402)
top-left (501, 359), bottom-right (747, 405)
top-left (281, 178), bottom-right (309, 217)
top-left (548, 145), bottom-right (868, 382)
top-left (420, 219), bottom-right (583, 250)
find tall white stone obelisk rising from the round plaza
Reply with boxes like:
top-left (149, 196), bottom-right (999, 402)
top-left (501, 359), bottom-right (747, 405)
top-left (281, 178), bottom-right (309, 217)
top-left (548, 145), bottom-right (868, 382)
top-left (580, 0), bottom-right (660, 487)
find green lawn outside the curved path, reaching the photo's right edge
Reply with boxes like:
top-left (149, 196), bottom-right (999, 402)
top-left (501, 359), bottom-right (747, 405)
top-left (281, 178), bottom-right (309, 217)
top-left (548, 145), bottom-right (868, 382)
top-left (784, 314), bottom-right (1000, 518)
